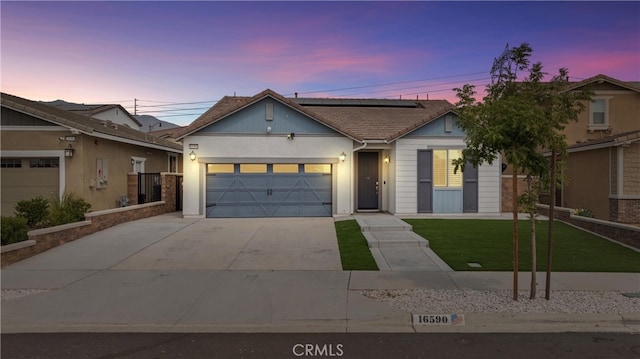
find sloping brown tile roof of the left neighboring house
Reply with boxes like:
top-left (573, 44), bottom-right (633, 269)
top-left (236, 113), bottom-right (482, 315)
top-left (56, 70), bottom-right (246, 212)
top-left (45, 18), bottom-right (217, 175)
top-left (1, 93), bottom-right (182, 152)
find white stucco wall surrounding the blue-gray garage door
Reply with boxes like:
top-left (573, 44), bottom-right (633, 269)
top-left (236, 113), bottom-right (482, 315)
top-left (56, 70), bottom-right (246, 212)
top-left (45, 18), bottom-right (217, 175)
top-left (183, 134), bottom-right (353, 217)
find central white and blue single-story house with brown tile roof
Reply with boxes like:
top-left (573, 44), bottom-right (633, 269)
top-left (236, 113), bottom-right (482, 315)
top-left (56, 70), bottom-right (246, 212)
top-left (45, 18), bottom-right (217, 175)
top-left (176, 90), bottom-right (500, 217)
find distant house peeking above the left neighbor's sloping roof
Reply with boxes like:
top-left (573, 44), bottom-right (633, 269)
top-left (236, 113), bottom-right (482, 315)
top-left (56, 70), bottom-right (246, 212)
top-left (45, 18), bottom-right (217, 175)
top-left (42, 100), bottom-right (142, 130)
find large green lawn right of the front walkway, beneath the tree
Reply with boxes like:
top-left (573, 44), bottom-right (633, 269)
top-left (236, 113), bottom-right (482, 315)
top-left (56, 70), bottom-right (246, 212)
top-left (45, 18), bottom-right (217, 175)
top-left (406, 219), bottom-right (640, 272)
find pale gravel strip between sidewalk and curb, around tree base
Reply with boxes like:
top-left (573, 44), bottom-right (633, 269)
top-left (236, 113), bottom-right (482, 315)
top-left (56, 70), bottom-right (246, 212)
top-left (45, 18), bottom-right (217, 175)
top-left (360, 289), bottom-right (640, 314)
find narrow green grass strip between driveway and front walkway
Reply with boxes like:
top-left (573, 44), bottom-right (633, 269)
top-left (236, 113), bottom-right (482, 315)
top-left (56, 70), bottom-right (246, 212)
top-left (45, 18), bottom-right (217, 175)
top-left (335, 220), bottom-right (378, 270)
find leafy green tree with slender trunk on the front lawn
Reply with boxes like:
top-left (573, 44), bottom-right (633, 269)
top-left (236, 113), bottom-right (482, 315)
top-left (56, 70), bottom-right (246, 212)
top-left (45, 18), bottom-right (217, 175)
top-left (454, 43), bottom-right (592, 300)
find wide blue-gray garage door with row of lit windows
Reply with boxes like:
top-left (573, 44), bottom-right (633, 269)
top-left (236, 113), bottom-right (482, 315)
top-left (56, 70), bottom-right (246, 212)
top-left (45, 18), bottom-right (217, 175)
top-left (206, 163), bottom-right (332, 218)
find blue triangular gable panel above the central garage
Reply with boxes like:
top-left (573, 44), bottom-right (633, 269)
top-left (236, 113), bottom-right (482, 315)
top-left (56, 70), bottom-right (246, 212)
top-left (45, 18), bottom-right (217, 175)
top-left (199, 98), bottom-right (337, 135)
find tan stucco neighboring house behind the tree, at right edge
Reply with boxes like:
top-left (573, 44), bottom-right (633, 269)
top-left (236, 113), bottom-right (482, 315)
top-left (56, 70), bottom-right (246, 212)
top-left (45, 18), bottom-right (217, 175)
top-left (547, 75), bottom-right (640, 224)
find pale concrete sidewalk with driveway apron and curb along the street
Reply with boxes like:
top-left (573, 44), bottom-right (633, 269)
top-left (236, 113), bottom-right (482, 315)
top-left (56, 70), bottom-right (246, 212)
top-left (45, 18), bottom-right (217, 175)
top-left (2, 270), bottom-right (640, 333)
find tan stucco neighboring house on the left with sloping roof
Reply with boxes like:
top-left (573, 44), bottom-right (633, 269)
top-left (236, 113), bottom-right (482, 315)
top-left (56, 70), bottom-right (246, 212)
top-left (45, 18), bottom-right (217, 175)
top-left (0, 93), bottom-right (182, 216)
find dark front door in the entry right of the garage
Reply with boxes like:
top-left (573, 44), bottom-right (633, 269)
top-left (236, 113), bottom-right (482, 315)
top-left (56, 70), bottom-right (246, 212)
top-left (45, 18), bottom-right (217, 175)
top-left (358, 152), bottom-right (380, 210)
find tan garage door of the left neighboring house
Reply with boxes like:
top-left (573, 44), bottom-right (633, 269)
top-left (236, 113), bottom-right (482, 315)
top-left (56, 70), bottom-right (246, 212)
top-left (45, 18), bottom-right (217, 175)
top-left (0, 157), bottom-right (60, 216)
